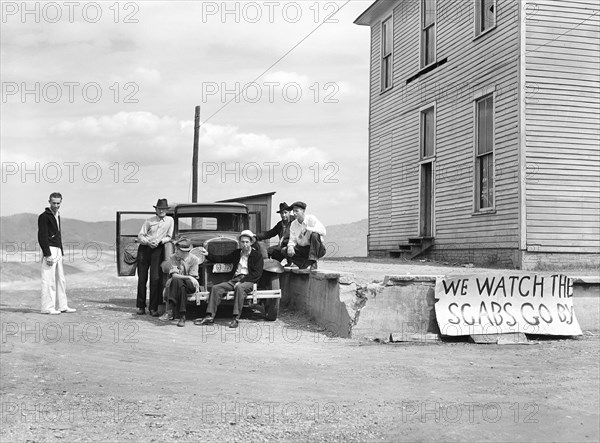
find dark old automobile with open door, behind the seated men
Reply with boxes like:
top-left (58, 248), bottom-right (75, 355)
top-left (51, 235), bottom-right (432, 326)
top-left (116, 202), bottom-right (283, 321)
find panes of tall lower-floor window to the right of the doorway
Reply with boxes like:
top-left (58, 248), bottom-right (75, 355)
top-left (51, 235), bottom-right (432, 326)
top-left (475, 94), bottom-right (494, 211)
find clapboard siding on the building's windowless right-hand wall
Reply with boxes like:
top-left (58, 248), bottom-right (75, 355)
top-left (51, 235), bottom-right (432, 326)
top-left (525, 0), bottom-right (600, 253)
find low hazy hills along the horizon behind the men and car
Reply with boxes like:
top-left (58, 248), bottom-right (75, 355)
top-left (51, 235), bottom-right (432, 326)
top-left (0, 214), bottom-right (367, 258)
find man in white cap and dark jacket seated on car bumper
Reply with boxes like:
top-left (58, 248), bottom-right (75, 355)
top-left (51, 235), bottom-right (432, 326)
top-left (194, 230), bottom-right (264, 328)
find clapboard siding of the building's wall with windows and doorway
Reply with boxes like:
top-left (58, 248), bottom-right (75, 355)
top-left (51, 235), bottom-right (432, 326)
top-left (369, 0), bottom-right (519, 250)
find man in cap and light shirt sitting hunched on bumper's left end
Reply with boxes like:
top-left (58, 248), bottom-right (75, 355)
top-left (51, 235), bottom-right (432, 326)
top-left (159, 238), bottom-right (200, 327)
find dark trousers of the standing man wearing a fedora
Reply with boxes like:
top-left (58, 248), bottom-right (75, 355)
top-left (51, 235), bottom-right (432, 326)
top-left (136, 244), bottom-right (165, 311)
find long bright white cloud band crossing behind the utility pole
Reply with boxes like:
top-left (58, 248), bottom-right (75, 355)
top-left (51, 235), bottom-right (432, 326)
top-left (49, 111), bottom-right (329, 167)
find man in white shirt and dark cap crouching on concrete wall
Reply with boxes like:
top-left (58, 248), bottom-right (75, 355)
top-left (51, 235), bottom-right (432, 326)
top-left (284, 202), bottom-right (326, 270)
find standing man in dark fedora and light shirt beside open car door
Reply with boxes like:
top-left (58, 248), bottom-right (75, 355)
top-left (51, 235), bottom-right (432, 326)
top-left (136, 198), bottom-right (175, 317)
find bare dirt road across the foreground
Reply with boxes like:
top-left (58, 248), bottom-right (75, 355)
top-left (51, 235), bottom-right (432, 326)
top-left (0, 286), bottom-right (600, 442)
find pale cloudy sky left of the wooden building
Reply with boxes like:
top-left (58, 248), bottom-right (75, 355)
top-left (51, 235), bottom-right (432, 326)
top-left (0, 0), bottom-right (373, 225)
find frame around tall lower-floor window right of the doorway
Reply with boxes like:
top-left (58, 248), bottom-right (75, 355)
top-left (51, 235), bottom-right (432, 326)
top-left (473, 90), bottom-right (496, 215)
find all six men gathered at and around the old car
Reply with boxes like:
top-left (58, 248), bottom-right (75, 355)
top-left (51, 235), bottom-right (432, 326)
top-left (38, 192), bottom-right (326, 328)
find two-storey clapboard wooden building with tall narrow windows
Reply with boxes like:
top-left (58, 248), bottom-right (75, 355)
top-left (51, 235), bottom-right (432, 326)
top-left (355, 0), bottom-right (600, 270)
